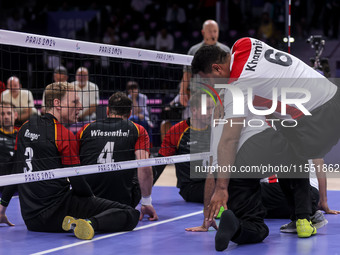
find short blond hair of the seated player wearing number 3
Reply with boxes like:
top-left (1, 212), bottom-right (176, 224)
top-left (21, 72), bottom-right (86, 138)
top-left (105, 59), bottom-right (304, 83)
top-left (45, 82), bottom-right (76, 110)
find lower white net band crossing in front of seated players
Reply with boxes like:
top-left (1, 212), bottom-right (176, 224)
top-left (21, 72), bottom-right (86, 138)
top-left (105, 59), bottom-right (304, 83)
top-left (0, 152), bottom-right (210, 186)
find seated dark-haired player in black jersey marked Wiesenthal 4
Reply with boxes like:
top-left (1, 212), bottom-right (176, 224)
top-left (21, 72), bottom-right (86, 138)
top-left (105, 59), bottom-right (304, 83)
top-left (77, 92), bottom-right (158, 220)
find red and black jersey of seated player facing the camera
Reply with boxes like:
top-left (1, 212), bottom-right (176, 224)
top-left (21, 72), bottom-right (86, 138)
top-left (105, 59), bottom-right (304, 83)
top-left (158, 119), bottom-right (210, 188)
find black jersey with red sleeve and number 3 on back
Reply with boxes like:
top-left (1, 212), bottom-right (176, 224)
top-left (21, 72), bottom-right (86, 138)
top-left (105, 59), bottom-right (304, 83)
top-left (15, 114), bottom-right (80, 220)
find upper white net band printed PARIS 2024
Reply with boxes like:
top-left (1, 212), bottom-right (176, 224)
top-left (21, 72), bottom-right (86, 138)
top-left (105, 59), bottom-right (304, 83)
top-left (0, 29), bottom-right (193, 65)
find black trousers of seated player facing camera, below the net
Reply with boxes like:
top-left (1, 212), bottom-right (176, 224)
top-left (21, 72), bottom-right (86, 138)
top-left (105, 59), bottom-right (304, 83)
top-left (179, 180), bottom-right (205, 203)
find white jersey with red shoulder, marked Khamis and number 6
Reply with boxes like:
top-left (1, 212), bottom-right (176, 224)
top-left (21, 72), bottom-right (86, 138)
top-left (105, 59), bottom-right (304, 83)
top-left (229, 37), bottom-right (337, 119)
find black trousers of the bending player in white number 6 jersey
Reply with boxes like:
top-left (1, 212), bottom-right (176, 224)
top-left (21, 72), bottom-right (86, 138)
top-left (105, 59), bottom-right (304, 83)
top-left (227, 128), bottom-right (311, 244)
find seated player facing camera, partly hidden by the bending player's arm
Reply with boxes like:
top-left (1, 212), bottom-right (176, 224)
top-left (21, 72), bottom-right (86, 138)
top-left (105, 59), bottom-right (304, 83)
top-left (154, 92), bottom-right (214, 203)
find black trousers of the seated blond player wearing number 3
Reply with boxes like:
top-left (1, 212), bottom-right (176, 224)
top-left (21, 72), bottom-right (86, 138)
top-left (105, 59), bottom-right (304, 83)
top-left (25, 194), bottom-right (139, 232)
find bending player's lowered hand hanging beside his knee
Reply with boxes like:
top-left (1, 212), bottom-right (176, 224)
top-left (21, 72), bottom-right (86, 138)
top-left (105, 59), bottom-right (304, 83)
top-left (205, 189), bottom-right (229, 221)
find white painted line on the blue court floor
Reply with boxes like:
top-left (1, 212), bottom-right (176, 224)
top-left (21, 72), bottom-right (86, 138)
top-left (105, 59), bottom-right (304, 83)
top-left (31, 210), bottom-right (203, 255)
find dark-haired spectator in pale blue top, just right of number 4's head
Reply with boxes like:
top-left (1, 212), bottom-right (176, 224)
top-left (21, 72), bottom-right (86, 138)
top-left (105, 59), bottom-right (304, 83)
top-left (126, 81), bottom-right (153, 136)
